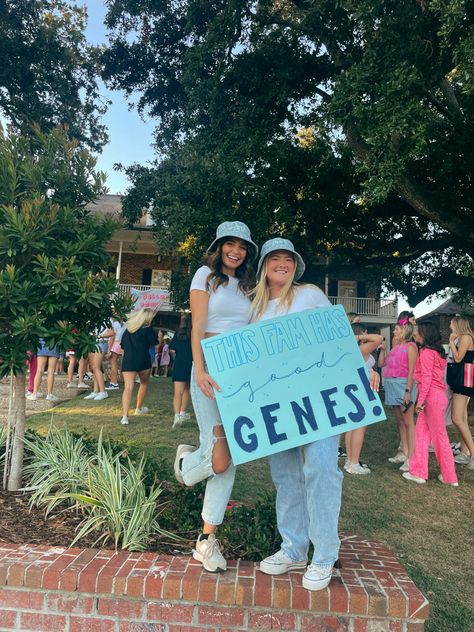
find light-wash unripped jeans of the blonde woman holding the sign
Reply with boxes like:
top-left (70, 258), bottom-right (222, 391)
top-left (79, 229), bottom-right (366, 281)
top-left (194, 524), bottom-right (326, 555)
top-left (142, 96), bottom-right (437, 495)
top-left (269, 435), bottom-right (343, 566)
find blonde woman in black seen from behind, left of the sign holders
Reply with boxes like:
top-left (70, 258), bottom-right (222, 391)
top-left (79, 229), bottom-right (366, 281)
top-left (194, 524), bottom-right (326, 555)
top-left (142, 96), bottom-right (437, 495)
top-left (120, 307), bottom-right (158, 426)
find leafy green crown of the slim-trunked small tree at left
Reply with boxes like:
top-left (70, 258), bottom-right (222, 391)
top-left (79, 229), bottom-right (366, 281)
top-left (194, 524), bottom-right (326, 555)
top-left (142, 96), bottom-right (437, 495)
top-left (0, 128), bottom-right (128, 375)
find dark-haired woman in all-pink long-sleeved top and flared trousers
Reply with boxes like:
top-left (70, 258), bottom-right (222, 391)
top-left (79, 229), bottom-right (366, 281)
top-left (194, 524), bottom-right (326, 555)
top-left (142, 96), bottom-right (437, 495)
top-left (403, 321), bottom-right (458, 487)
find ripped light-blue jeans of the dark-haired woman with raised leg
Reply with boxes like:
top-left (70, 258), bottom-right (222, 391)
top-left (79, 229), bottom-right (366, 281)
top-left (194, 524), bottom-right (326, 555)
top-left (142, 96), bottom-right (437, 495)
top-left (181, 367), bottom-right (235, 526)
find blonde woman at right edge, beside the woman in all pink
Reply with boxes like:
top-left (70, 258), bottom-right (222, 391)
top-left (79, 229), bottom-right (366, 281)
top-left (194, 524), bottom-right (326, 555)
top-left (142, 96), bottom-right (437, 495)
top-left (448, 316), bottom-right (474, 470)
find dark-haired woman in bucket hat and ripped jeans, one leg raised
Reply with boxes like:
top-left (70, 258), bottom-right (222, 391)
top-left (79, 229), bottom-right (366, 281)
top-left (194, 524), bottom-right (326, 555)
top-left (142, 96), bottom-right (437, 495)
top-left (175, 222), bottom-right (258, 572)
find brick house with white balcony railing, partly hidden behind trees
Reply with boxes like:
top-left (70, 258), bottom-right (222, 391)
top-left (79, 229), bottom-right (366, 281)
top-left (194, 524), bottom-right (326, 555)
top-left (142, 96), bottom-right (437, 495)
top-left (89, 195), bottom-right (397, 340)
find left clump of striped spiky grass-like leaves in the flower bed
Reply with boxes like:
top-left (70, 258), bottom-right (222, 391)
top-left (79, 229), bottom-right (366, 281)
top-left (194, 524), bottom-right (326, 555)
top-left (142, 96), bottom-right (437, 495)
top-left (23, 426), bottom-right (94, 515)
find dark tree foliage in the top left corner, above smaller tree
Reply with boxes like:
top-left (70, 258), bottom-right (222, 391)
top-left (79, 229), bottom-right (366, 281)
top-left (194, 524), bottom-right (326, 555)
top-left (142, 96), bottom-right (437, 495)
top-left (0, 0), bottom-right (107, 150)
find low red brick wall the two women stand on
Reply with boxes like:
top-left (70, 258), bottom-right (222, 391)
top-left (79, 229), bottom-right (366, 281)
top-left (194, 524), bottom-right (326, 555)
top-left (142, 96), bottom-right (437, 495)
top-left (0, 536), bottom-right (429, 632)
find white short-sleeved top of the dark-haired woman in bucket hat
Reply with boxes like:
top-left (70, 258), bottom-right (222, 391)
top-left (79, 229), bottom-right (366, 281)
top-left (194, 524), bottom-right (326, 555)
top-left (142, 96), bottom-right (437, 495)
top-left (190, 266), bottom-right (250, 334)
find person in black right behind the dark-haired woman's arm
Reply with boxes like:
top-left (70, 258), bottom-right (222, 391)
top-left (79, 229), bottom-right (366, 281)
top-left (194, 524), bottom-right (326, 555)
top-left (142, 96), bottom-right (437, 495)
top-left (170, 313), bottom-right (193, 428)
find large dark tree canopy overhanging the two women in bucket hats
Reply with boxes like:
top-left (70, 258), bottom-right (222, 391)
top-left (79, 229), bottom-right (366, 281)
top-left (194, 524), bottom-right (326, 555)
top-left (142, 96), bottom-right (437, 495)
top-left (104, 0), bottom-right (474, 303)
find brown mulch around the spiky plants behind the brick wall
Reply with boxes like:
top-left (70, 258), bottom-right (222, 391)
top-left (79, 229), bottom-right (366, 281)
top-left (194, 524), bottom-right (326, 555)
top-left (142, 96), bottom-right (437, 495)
top-left (0, 490), bottom-right (190, 555)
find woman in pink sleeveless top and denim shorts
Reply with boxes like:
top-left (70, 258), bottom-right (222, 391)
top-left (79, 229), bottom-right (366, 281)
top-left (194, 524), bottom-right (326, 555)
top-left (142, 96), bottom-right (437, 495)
top-left (379, 318), bottom-right (418, 472)
